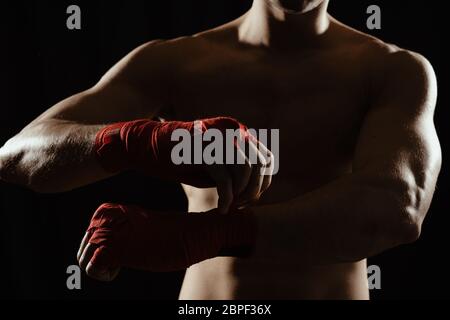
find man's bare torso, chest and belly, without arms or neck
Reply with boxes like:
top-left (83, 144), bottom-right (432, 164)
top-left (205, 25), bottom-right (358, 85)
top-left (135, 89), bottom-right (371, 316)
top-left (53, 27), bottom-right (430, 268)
top-left (156, 17), bottom-right (388, 299)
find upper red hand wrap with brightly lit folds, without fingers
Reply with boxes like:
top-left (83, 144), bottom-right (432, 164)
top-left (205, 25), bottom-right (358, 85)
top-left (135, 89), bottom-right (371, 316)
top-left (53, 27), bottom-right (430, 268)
top-left (95, 118), bottom-right (248, 188)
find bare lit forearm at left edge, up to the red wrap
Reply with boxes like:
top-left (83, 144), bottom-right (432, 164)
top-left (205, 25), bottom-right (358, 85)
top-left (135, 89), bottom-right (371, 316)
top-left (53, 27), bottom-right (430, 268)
top-left (0, 119), bottom-right (108, 193)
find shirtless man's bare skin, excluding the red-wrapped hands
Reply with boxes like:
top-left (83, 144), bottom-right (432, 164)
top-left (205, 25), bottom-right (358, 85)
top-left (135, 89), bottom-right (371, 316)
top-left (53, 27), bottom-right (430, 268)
top-left (0, 0), bottom-right (441, 299)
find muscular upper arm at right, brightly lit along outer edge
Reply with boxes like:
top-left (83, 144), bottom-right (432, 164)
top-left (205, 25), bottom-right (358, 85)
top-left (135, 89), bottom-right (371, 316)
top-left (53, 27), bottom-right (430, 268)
top-left (353, 51), bottom-right (441, 219)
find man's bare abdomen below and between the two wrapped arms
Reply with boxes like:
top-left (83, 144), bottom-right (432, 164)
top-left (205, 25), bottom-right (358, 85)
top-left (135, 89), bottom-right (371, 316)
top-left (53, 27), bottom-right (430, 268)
top-left (180, 182), bottom-right (369, 300)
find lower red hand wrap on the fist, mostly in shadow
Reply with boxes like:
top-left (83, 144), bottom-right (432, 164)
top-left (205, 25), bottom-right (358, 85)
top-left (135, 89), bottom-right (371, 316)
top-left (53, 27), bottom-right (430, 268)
top-left (88, 204), bottom-right (257, 272)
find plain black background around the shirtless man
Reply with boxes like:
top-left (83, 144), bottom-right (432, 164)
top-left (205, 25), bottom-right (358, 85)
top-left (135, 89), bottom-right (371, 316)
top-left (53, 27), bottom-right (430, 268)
top-left (0, 0), bottom-right (450, 299)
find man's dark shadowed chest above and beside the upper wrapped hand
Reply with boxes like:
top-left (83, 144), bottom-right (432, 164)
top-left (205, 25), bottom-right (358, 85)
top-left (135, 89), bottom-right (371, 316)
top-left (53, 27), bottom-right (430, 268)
top-left (173, 52), bottom-right (366, 184)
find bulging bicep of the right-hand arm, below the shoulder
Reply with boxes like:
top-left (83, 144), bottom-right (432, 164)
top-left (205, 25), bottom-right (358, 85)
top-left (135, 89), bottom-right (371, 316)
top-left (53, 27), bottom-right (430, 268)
top-left (353, 101), bottom-right (441, 192)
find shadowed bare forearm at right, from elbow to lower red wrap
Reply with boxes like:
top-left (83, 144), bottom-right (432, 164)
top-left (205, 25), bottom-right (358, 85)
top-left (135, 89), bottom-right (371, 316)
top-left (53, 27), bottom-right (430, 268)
top-left (255, 175), bottom-right (431, 264)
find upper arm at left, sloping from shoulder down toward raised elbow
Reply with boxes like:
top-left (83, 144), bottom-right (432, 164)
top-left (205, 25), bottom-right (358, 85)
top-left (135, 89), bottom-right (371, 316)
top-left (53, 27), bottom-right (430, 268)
top-left (28, 42), bottom-right (169, 125)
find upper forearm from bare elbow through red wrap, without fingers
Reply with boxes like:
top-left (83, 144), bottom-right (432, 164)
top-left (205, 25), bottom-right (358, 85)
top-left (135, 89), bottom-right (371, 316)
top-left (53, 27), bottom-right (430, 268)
top-left (0, 118), bottom-right (246, 192)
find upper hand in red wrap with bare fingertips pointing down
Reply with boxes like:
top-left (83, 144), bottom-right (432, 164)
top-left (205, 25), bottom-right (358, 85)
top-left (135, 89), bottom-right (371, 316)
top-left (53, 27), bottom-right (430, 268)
top-left (95, 117), bottom-right (274, 213)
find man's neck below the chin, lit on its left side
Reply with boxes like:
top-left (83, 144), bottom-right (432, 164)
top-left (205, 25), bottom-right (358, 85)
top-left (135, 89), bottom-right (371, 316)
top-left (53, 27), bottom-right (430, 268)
top-left (239, 0), bottom-right (330, 49)
